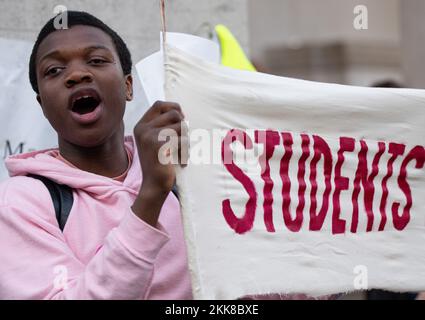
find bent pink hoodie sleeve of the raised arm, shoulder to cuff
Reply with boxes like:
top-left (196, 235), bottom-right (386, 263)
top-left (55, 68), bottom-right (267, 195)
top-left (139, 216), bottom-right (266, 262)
top-left (0, 179), bottom-right (169, 299)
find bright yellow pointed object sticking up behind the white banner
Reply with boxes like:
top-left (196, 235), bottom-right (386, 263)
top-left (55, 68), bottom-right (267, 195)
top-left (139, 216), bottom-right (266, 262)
top-left (215, 24), bottom-right (256, 71)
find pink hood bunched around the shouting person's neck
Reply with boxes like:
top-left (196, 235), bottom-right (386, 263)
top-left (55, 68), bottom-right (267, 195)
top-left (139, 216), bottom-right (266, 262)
top-left (5, 136), bottom-right (142, 199)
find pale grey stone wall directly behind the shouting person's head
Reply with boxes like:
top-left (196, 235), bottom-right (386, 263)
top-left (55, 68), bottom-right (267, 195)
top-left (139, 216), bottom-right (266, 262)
top-left (0, 0), bottom-right (248, 62)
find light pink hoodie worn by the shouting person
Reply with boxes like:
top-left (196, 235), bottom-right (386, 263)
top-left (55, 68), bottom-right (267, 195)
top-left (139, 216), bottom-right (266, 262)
top-left (0, 137), bottom-right (192, 299)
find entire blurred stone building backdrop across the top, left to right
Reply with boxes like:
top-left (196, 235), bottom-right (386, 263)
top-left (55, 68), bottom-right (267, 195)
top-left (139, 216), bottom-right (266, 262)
top-left (0, 0), bottom-right (425, 88)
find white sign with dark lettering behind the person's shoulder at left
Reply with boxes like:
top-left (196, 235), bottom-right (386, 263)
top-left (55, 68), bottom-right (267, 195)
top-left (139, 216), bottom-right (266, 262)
top-left (0, 39), bottom-right (56, 180)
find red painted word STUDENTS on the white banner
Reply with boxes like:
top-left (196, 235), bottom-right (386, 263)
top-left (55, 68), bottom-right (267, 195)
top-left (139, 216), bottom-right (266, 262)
top-left (221, 129), bottom-right (425, 235)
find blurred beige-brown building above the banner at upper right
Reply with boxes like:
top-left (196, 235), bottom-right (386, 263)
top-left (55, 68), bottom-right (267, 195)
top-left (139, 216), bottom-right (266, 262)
top-left (248, 0), bottom-right (425, 88)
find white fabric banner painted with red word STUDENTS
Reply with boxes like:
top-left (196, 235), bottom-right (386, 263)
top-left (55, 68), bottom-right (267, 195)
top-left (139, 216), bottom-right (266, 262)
top-left (165, 47), bottom-right (425, 299)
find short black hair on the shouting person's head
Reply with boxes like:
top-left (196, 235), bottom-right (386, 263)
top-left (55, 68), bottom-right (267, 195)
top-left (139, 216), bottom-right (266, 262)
top-left (29, 11), bottom-right (132, 94)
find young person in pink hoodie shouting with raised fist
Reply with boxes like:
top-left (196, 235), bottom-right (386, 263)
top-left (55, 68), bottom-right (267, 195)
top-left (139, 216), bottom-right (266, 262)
top-left (0, 11), bottom-right (192, 299)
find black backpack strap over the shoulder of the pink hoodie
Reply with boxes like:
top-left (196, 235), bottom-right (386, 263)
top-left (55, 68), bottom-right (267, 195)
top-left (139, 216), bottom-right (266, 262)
top-left (28, 174), bottom-right (74, 231)
